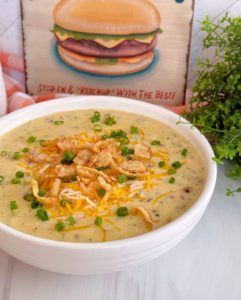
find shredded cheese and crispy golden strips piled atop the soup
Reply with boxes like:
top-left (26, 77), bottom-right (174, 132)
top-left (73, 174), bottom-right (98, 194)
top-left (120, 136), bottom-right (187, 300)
top-left (18, 129), bottom-right (179, 241)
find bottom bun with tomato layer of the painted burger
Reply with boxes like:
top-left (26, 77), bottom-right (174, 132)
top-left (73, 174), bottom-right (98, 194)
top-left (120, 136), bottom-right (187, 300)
top-left (58, 46), bottom-right (154, 75)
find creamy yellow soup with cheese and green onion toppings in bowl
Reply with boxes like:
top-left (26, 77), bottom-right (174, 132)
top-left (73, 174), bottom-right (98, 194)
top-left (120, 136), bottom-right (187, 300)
top-left (0, 110), bottom-right (205, 242)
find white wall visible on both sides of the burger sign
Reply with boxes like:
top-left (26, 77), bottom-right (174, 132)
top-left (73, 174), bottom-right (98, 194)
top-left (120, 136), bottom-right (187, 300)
top-left (0, 0), bottom-right (241, 87)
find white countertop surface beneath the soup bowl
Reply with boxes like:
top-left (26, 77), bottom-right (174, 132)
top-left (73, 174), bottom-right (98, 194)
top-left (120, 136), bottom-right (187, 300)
top-left (0, 167), bottom-right (241, 300)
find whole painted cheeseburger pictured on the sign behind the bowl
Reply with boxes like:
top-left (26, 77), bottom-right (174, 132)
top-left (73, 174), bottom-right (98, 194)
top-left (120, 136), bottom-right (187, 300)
top-left (53, 0), bottom-right (161, 75)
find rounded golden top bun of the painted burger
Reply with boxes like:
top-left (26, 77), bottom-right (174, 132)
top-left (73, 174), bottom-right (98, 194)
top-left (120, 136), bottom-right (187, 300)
top-left (53, 0), bottom-right (161, 35)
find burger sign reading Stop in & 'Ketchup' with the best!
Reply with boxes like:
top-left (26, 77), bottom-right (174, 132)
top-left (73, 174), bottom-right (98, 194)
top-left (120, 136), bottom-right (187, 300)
top-left (22, 0), bottom-right (194, 105)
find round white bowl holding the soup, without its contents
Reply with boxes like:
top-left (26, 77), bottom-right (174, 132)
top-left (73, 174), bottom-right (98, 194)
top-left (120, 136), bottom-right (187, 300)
top-left (0, 96), bottom-right (217, 275)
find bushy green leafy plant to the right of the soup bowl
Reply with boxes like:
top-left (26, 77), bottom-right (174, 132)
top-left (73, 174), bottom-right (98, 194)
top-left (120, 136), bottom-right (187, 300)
top-left (184, 14), bottom-right (241, 195)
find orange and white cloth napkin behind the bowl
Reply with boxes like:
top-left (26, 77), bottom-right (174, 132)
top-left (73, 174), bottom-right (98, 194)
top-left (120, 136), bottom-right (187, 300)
top-left (0, 52), bottom-right (186, 116)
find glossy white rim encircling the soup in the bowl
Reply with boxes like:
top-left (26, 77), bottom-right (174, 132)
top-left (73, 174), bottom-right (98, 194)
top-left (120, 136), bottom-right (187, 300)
top-left (0, 95), bottom-right (217, 250)
